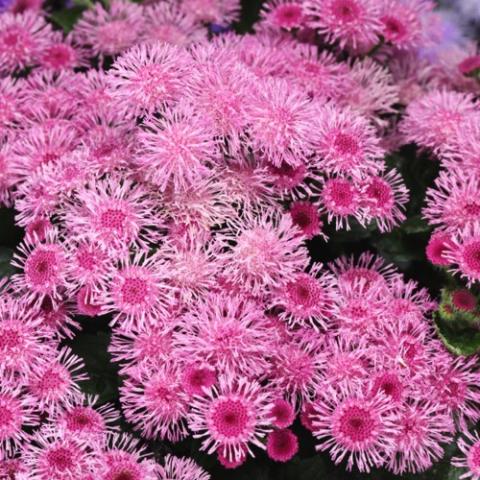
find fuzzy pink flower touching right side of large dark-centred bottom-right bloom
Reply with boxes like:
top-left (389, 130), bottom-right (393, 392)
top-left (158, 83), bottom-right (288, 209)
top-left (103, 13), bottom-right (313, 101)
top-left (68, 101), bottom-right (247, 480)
top-left (388, 401), bottom-right (455, 475)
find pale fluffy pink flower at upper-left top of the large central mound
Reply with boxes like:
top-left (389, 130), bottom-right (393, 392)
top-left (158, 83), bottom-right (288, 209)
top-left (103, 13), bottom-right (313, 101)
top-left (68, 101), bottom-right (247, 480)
top-left (109, 42), bottom-right (190, 116)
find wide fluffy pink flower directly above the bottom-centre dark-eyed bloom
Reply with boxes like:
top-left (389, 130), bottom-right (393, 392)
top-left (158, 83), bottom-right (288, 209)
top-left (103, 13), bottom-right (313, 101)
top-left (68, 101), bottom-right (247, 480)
top-left (173, 294), bottom-right (272, 378)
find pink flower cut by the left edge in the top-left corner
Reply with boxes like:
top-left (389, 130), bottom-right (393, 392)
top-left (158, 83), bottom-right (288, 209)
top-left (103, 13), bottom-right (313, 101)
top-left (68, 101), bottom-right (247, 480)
top-left (0, 11), bottom-right (51, 74)
